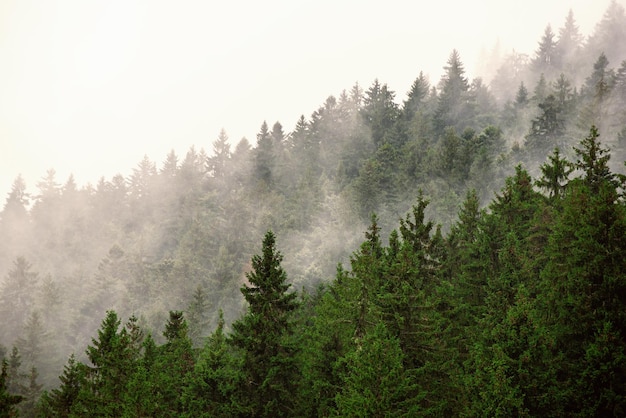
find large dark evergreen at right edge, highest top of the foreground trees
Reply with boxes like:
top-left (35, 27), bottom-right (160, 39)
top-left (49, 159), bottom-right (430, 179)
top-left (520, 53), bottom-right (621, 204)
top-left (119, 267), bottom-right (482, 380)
top-left (539, 127), bottom-right (626, 416)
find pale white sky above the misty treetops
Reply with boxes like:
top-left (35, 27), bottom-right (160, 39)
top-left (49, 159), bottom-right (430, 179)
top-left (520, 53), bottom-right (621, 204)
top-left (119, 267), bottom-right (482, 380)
top-left (0, 0), bottom-right (626, 199)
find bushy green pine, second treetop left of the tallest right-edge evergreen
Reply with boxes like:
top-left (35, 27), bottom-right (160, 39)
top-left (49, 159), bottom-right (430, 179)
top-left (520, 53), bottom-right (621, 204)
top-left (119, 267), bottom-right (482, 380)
top-left (465, 166), bottom-right (549, 416)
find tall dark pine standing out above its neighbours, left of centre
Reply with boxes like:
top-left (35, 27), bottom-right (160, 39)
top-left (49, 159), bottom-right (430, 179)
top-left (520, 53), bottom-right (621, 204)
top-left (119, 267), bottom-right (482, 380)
top-left (229, 231), bottom-right (298, 416)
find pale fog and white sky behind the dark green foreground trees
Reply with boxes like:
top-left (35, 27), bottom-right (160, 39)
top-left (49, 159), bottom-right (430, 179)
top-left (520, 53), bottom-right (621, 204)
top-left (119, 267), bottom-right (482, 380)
top-left (0, 1), bottom-right (626, 396)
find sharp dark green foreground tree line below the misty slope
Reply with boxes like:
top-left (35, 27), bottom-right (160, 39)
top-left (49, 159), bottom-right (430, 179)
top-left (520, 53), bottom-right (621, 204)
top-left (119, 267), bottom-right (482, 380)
top-left (0, 126), bottom-right (626, 417)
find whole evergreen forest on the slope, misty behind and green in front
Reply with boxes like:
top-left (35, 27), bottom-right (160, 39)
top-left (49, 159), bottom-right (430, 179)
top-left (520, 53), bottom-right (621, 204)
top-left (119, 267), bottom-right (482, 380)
top-left (0, 1), bottom-right (626, 417)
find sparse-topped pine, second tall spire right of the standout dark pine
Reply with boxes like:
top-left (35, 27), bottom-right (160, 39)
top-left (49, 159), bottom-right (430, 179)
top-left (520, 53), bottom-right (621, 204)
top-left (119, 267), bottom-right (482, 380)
top-left (380, 196), bottom-right (458, 415)
